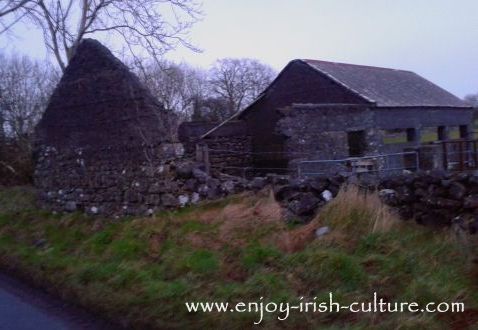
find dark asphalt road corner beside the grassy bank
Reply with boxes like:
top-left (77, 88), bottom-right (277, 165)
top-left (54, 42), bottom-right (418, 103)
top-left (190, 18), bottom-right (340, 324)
top-left (0, 273), bottom-right (118, 330)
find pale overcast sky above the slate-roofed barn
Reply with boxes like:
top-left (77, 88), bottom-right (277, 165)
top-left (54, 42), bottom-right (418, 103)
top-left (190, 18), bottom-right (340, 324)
top-left (0, 0), bottom-right (478, 97)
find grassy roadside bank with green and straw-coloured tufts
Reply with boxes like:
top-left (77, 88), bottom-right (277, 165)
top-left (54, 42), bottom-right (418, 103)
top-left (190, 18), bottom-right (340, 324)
top-left (0, 188), bottom-right (478, 329)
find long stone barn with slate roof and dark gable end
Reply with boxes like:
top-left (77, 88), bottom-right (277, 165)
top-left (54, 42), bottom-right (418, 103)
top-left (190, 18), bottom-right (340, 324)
top-left (192, 60), bottom-right (472, 177)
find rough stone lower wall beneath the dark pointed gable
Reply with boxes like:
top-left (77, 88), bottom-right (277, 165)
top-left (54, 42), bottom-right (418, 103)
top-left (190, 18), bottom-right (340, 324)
top-left (35, 144), bottom-right (186, 214)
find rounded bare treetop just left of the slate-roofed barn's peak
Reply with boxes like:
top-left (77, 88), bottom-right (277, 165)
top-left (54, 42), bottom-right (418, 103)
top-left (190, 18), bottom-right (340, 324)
top-left (209, 58), bottom-right (276, 117)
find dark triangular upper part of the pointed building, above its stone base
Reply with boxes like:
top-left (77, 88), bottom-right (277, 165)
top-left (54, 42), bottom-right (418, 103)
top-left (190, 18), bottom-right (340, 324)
top-left (37, 39), bottom-right (173, 148)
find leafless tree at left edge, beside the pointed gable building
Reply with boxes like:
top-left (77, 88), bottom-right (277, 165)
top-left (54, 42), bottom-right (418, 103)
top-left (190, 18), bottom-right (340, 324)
top-left (0, 53), bottom-right (59, 184)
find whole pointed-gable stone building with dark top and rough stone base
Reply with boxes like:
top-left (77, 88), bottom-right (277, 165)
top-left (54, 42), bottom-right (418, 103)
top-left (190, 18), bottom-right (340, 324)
top-left (35, 39), bottom-right (182, 214)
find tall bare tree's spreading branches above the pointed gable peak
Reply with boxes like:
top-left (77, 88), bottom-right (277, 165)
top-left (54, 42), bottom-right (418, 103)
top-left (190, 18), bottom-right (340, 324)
top-left (0, 0), bottom-right (201, 70)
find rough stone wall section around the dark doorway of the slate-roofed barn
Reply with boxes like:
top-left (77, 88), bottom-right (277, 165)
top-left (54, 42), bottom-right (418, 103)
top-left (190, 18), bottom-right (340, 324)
top-left (276, 105), bottom-right (382, 174)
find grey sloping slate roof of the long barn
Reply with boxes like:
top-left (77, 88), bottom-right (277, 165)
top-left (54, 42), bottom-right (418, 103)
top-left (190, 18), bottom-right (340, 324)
top-left (301, 59), bottom-right (467, 107)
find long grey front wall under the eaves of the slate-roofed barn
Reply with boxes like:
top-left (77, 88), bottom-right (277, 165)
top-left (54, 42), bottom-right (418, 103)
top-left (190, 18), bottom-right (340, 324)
top-left (277, 105), bottom-right (472, 177)
